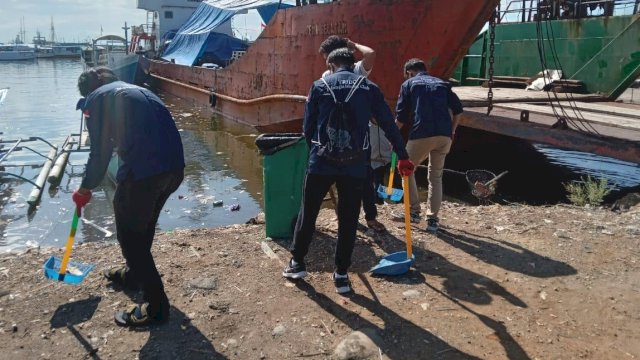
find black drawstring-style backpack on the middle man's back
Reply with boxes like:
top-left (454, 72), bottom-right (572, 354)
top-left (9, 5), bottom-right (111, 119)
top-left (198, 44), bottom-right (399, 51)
top-left (317, 76), bottom-right (369, 166)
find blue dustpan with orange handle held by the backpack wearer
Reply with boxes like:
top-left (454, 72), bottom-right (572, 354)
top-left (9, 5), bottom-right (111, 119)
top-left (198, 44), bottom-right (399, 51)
top-left (369, 176), bottom-right (416, 276)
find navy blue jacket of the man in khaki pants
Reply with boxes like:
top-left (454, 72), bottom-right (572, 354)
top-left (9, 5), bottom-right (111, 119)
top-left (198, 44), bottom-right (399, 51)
top-left (396, 72), bottom-right (462, 139)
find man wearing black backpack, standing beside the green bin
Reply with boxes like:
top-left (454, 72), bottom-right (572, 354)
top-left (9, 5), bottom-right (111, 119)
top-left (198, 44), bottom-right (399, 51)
top-left (282, 48), bottom-right (414, 294)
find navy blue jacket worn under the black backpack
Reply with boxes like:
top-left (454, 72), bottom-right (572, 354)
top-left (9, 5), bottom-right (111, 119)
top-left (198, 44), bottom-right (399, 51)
top-left (303, 68), bottom-right (409, 179)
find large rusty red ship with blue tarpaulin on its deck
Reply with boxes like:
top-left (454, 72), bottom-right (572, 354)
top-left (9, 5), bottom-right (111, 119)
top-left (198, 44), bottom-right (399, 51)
top-left (138, 0), bottom-right (498, 132)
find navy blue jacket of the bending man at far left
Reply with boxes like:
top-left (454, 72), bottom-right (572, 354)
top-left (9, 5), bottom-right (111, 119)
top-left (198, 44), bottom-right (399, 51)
top-left (81, 81), bottom-right (184, 189)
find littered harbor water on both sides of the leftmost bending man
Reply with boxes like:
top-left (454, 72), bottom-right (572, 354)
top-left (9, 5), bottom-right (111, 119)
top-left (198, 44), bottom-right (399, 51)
top-left (0, 59), bottom-right (262, 252)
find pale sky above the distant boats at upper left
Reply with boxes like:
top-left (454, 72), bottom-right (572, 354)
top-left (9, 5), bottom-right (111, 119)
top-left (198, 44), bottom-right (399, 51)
top-left (0, 0), bottom-right (146, 43)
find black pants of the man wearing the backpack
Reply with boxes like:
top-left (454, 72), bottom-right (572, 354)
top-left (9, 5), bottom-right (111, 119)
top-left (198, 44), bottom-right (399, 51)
top-left (289, 174), bottom-right (364, 274)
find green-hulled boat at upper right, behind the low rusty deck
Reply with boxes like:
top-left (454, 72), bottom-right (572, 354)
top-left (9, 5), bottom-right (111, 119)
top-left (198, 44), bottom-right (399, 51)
top-left (452, 0), bottom-right (640, 100)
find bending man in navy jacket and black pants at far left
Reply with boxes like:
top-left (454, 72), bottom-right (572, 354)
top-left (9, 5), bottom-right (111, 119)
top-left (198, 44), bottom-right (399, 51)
top-left (73, 67), bottom-right (185, 326)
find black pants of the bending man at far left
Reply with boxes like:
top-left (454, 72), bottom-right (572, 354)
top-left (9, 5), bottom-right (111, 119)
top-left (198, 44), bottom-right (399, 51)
top-left (113, 169), bottom-right (184, 314)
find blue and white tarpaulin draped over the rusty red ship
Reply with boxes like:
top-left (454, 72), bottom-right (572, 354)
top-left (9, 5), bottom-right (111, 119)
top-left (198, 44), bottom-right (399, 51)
top-left (162, 0), bottom-right (291, 65)
